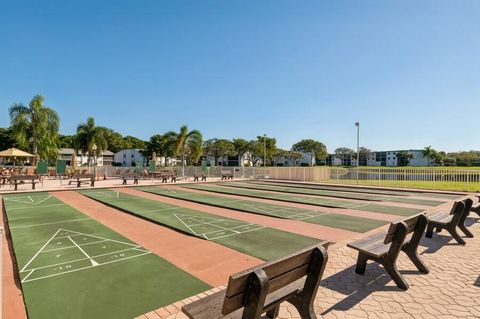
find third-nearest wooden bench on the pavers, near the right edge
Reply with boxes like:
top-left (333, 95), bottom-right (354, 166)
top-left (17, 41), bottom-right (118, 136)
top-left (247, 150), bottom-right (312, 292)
top-left (426, 198), bottom-right (473, 245)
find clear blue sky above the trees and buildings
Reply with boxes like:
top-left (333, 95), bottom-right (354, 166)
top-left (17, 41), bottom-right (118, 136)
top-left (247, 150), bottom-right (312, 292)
top-left (0, 0), bottom-right (480, 151)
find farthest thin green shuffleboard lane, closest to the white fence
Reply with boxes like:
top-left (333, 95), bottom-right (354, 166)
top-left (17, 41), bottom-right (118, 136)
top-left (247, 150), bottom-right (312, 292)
top-left (251, 180), bottom-right (464, 200)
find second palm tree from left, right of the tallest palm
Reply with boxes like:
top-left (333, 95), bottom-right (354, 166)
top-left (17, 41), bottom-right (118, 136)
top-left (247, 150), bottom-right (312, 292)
top-left (75, 117), bottom-right (107, 166)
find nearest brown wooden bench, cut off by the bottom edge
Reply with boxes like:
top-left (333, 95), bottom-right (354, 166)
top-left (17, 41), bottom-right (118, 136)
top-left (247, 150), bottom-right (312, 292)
top-left (182, 243), bottom-right (328, 319)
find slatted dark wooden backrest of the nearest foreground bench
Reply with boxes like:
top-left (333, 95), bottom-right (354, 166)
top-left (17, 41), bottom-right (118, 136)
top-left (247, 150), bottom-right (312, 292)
top-left (222, 243), bottom-right (328, 318)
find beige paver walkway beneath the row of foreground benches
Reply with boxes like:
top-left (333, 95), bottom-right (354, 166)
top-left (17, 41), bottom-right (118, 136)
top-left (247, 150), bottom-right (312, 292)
top-left (138, 215), bottom-right (480, 319)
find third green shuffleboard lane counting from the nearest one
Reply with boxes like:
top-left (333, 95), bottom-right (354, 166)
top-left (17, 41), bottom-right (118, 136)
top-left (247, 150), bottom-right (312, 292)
top-left (137, 186), bottom-right (387, 233)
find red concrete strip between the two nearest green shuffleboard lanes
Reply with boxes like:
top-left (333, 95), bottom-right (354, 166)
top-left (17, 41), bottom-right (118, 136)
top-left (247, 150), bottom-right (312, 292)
top-left (51, 191), bottom-right (263, 287)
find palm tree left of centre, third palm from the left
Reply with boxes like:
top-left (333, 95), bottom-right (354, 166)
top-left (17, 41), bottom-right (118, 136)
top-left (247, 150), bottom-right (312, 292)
top-left (165, 125), bottom-right (202, 175)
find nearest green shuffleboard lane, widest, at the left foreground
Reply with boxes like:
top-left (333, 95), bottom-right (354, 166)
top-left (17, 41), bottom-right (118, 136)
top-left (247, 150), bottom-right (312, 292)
top-left (3, 193), bottom-right (210, 319)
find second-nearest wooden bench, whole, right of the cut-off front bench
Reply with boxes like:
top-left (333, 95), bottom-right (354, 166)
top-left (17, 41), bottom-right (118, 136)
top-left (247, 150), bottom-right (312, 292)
top-left (347, 214), bottom-right (430, 290)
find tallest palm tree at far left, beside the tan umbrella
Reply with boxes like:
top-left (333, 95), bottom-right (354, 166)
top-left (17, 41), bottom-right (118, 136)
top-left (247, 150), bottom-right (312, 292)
top-left (9, 95), bottom-right (60, 164)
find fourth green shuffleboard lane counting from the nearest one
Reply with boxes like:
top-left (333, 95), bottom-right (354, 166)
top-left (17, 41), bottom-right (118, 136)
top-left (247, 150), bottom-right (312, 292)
top-left (181, 184), bottom-right (423, 216)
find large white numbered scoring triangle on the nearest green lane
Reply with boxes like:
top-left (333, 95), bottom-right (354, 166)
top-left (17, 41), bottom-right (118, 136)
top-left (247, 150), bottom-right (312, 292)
top-left (20, 228), bottom-right (151, 283)
